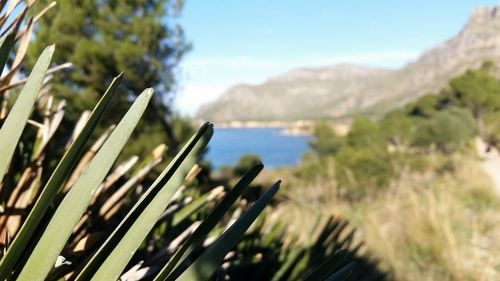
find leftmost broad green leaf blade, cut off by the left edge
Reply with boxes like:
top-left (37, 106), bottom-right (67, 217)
top-left (0, 45), bottom-right (54, 183)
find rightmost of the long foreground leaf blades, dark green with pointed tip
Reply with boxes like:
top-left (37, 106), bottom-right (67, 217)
top-left (174, 179), bottom-right (280, 281)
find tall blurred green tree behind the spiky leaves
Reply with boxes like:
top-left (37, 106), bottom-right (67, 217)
top-left (27, 0), bottom-right (189, 152)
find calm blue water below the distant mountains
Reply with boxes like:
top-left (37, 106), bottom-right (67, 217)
top-left (205, 128), bottom-right (311, 169)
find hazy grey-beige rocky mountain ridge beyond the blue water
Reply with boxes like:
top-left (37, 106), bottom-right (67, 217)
top-left (196, 6), bottom-right (500, 122)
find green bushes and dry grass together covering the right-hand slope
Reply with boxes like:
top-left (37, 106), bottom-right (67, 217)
top-left (272, 63), bottom-right (500, 281)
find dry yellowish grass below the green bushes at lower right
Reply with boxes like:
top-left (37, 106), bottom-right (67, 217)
top-left (268, 156), bottom-right (500, 281)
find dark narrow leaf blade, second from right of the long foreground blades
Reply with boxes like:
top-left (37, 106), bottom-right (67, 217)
top-left (155, 164), bottom-right (264, 281)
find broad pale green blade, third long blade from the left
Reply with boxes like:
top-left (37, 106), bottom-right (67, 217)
top-left (17, 89), bottom-right (153, 281)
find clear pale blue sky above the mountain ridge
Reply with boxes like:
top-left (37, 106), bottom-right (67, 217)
top-left (176, 0), bottom-right (500, 115)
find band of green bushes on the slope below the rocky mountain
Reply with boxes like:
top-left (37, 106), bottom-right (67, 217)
top-left (300, 63), bottom-right (500, 196)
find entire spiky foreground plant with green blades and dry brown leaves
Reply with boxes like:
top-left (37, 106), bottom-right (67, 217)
top-left (0, 1), bottom-right (383, 281)
